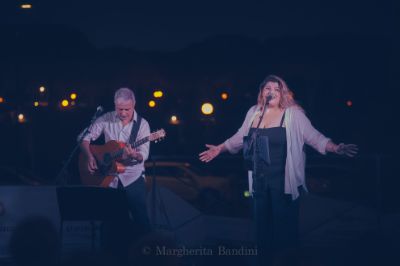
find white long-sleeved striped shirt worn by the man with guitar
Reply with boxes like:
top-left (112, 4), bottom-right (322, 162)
top-left (79, 111), bottom-right (150, 187)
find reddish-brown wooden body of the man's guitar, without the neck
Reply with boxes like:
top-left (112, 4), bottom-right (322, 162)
top-left (79, 140), bottom-right (125, 187)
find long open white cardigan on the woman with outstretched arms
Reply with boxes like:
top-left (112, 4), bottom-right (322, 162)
top-left (224, 105), bottom-right (330, 200)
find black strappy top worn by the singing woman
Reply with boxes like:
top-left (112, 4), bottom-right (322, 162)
top-left (249, 113), bottom-right (287, 191)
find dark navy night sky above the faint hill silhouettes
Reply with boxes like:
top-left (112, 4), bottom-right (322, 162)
top-left (2, 0), bottom-right (396, 50)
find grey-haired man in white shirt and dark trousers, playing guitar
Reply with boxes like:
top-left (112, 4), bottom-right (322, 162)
top-left (80, 88), bottom-right (150, 233)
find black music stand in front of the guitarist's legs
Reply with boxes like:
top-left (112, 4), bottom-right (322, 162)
top-left (56, 186), bottom-right (129, 250)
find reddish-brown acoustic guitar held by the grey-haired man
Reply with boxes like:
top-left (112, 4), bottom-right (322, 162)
top-left (79, 129), bottom-right (166, 187)
